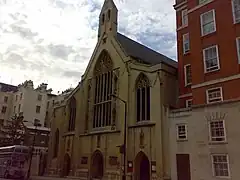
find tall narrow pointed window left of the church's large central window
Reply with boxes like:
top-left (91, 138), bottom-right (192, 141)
top-left (68, 97), bottom-right (76, 131)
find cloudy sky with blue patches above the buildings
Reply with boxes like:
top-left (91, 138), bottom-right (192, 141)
top-left (0, 0), bottom-right (176, 92)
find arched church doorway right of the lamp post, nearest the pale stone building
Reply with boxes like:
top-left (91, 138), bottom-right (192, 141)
top-left (134, 151), bottom-right (150, 180)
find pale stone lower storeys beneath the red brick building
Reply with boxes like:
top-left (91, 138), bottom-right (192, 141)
top-left (169, 101), bottom-right (240, 180)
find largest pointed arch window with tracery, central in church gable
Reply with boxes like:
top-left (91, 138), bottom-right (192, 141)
top-left (93, 51), bottom-right (113, 128)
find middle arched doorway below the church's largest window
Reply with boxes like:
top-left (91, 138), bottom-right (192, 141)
top-left (91, 151), bottom-right (103, 179)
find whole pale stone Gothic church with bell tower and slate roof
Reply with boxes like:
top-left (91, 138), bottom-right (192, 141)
top-left (47, 0), bottom-right (178, 180)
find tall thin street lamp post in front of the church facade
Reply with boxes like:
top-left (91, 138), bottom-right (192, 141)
top-left (111, 94), bottom-right (127, 180)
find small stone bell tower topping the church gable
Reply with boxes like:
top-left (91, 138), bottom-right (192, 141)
top-left (98, 0), bottom-right (118, 38)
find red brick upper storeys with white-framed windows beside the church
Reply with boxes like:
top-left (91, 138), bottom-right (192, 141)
top-left (174, 0), bottom-right (240, 107)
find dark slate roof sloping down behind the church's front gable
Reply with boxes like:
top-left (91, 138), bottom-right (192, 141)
top-left (117, 33), bottom-right (177, 68)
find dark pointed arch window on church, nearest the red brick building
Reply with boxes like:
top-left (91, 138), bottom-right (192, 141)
top-left (136, 73), bottom-right (150, 122)
